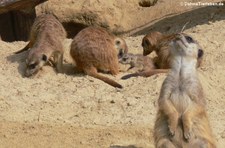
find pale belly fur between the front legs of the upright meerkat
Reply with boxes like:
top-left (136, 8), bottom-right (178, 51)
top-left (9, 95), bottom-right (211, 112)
top-left (170, 88), bottom-right (192, 115)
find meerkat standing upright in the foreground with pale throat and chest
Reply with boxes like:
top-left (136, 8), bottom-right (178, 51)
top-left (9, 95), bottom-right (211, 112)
top-left (154, 33), bottom-right (216, 148)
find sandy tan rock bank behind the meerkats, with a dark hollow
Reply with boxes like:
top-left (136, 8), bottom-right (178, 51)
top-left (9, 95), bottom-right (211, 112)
top-left (36, 0), bottom-right (220, 37)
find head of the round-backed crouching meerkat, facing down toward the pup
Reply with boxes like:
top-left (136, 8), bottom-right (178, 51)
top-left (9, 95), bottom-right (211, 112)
top-left (114, 37), bottom-right (128, 59)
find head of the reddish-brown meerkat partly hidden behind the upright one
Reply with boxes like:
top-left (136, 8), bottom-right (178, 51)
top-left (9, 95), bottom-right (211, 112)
top-left (141, 31), bottom-right (163, 56)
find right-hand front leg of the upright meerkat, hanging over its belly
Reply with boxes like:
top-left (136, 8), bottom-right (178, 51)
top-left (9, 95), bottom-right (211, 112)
top-left (182, 104), bottom-right (204, 141)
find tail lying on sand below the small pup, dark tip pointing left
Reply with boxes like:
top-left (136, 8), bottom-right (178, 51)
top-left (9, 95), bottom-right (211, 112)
top-left (121, 69), bottom-right (169, 80)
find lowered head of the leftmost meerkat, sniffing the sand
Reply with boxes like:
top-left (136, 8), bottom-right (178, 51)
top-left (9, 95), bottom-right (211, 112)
top-left (25, 53), bottom-right (48, 77)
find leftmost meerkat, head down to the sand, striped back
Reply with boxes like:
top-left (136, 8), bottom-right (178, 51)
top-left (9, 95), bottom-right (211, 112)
top-left (15, 14), bottom-right (66, 77)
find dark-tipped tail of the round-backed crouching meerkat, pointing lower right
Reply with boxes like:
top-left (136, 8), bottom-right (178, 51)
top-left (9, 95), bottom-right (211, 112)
top-left (88, 72), bottom-right (123, 88)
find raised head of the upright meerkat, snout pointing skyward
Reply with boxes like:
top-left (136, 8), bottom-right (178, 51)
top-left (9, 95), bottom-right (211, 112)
top-left (172, 33), bottom-right (204, 59)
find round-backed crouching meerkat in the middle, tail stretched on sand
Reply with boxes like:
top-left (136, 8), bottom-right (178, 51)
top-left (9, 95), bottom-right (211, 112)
top-left (70, 27), bottom-right (128, 88)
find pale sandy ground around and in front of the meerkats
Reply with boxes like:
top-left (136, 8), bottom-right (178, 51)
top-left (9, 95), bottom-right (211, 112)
top-left (0, 3), bottom-right (225, 148)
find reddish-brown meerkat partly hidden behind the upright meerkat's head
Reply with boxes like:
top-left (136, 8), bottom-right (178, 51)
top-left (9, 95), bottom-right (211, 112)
top-left (142, 31), bottom-right (203, 69)
